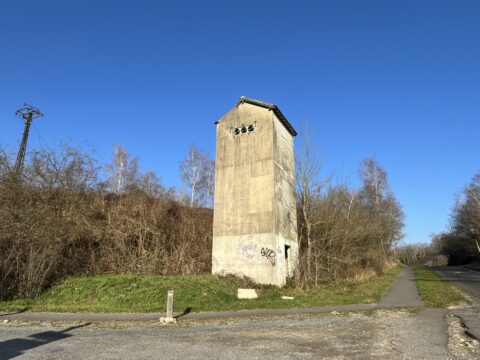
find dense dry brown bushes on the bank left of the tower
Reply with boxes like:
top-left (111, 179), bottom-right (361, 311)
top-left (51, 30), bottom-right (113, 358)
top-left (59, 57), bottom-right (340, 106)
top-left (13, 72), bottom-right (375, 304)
top-left (0, 146), bottom-right (212, 299)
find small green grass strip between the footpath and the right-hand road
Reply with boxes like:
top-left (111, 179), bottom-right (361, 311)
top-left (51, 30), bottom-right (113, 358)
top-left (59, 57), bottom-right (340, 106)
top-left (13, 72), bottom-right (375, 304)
top-left (413, 267), bottom-right (463, 308)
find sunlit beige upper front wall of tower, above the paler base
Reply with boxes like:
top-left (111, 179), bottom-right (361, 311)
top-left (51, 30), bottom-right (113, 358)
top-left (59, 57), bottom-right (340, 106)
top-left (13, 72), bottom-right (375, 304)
top-left (213, 104), bottom-right (274, 236)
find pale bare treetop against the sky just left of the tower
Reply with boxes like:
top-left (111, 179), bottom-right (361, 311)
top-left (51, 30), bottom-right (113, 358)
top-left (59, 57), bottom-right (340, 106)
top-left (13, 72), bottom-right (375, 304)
top-left (179, 145), bottom-right (215, 207)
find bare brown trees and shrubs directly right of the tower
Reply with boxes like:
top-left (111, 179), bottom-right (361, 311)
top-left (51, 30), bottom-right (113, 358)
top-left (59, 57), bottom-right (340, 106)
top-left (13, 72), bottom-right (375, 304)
top-left (297, 141), bottom-right (403, 287)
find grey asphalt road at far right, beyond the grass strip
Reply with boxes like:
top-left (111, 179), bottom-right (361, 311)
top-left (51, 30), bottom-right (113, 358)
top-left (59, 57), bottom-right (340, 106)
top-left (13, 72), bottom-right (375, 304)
top-left (435, 266), bottom-right (480, 300)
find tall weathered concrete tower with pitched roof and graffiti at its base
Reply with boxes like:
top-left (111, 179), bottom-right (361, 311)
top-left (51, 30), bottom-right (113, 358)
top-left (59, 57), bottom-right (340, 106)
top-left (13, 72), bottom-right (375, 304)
top-left (212, 97), bottom-right (298, 286)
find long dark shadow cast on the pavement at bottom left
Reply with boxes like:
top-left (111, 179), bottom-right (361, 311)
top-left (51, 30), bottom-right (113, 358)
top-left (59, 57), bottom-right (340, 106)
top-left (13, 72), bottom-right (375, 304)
top-left (0, 323), bottom-right (90, 360)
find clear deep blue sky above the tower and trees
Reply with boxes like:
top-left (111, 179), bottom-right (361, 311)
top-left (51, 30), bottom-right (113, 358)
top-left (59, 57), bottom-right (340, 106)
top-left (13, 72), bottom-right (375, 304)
top-left (0, 0), bottom-right (480, 242)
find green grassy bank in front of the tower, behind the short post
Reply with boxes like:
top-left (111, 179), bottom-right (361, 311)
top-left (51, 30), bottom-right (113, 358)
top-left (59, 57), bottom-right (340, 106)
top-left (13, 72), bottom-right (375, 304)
top-left (0, 267), bottom-right (401, 312)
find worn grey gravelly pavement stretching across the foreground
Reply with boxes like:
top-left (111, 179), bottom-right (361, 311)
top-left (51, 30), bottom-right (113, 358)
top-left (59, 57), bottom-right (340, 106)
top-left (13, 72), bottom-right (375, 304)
top-left (0, 309), bottom-right (479, 359)
